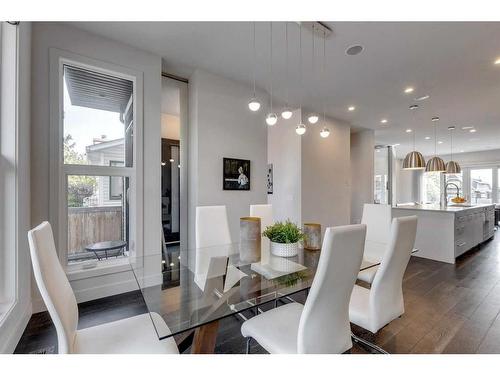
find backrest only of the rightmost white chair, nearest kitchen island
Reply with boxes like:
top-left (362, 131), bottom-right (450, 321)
top-left (370, 216), bottom-right (417, 332)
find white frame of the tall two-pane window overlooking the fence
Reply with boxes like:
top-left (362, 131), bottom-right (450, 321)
top-left (49, 48), bottom-right (143, 277)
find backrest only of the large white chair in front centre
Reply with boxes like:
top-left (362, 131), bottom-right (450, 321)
top-left (297, 224), bottom-right (366, 353)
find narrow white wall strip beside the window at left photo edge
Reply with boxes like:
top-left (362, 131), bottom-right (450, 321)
top-left (0, 22), bottom-right (31, 353)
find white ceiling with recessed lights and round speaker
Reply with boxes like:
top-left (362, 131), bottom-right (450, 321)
top-left (67, 22), bottom-right (500, 155)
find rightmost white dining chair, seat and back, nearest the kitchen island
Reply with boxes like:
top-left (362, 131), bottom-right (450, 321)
top-left (349, 216), bottom-right (417, 333)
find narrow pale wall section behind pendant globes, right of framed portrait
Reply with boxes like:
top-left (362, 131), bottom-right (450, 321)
top-left (267, 110), bottom-right (302, 225)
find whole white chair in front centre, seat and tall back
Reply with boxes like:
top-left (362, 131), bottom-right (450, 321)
top-left (241, 224), bottom-right (366, 354)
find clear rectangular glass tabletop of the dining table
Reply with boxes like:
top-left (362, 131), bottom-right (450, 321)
top-left (130, 241), bottom-right (379, 339)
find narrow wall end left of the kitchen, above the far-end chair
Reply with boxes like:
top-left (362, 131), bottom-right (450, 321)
top-left (350, 130), bottom-right (375, 224)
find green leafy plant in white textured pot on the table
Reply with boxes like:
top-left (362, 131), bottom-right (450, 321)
top-left (262, 220), bottom-right (304, 257)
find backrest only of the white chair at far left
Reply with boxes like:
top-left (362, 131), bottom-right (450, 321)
top-left (28, 221), bottom-right (78, 353)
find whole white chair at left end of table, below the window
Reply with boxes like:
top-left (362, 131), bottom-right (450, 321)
top-left (28, 221), bottom-right (179, 354)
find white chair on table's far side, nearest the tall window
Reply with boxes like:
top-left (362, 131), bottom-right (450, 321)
top-left (194, 206), bottom-right (232, 290)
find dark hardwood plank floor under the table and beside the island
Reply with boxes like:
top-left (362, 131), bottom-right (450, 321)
top-left (15, 232), bottom-right (500, 354)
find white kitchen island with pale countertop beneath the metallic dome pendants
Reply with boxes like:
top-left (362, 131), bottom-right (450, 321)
top-left (392, 204), bottom-right (495, 264)
